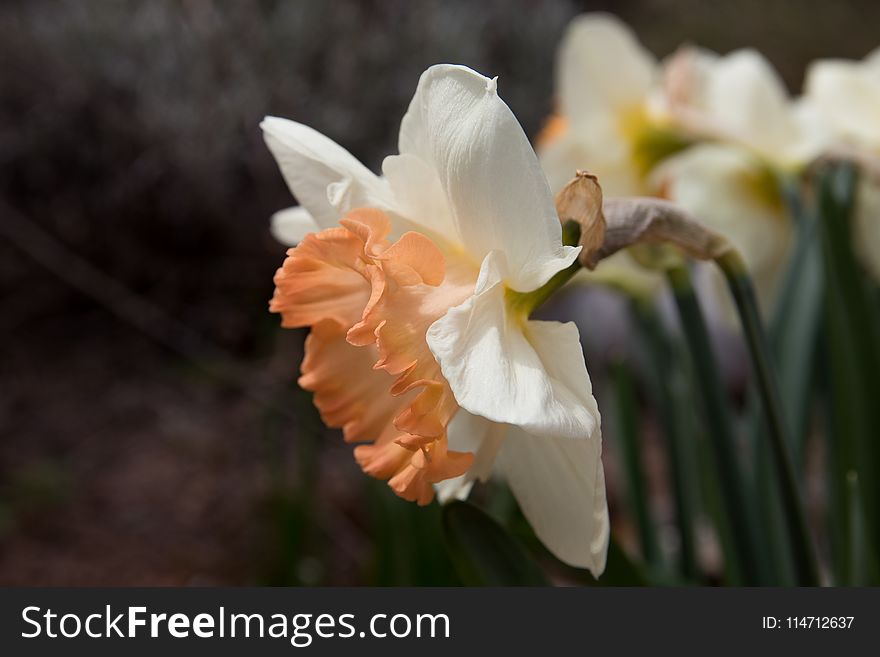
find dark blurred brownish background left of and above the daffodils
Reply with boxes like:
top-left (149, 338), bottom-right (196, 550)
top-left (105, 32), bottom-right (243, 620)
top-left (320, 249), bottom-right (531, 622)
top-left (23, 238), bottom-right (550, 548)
top-left (0, 0), bottom-right (880, 585)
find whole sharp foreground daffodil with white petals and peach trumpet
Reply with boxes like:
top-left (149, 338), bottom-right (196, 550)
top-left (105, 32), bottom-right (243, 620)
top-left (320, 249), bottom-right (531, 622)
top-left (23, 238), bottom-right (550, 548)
top-left (262, 65), bottom-right (609, 575)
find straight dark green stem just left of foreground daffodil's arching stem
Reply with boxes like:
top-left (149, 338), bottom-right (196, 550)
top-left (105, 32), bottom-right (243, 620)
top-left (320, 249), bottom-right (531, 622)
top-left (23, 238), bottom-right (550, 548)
top-left (667, 265), bottom-right (763, 586)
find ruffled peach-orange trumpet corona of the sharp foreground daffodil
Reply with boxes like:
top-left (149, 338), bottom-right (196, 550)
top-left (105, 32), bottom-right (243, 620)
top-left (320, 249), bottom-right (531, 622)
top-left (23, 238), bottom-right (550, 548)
top-left (270, 209), bottom-right (476, 505)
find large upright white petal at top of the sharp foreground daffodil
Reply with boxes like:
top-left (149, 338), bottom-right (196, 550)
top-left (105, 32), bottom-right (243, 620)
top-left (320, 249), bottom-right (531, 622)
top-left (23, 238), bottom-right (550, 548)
top-left (395, 65), bottom-right (578, 291)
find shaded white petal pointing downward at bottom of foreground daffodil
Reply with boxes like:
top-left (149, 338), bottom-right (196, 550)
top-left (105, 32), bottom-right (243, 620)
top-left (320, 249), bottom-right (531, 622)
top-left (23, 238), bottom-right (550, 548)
top-left (498, 426), bottom-right (610, 577)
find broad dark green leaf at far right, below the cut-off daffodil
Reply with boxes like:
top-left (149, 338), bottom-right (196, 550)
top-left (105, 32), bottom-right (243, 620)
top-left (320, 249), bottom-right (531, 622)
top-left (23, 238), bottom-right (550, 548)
top-left (818, 164), bottom-right (880, 582)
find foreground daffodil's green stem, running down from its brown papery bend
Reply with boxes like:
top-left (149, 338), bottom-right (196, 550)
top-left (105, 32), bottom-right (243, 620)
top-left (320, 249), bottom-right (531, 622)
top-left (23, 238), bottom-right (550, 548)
top-left (716, 250), bottom-right (819, 586)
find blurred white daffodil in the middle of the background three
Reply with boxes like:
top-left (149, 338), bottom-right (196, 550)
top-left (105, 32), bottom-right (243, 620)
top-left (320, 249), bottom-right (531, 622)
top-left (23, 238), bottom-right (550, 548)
top-left (651, 48), bottom-right (826, 326)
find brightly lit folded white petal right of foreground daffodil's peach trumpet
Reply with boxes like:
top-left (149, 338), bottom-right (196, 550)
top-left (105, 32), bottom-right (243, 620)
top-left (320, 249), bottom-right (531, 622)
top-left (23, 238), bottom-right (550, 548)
top-left (427, 255), bottom-right (599, 439)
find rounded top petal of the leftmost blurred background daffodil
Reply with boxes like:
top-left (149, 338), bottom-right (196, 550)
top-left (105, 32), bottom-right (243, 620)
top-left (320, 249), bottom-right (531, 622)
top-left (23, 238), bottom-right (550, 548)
top-left (557, 14), bottom-right (657, 125)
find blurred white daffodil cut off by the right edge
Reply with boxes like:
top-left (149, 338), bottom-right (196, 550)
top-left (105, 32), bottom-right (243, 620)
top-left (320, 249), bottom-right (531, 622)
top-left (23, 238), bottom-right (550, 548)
top-left (806, 48), bottom-right (880, 281)
